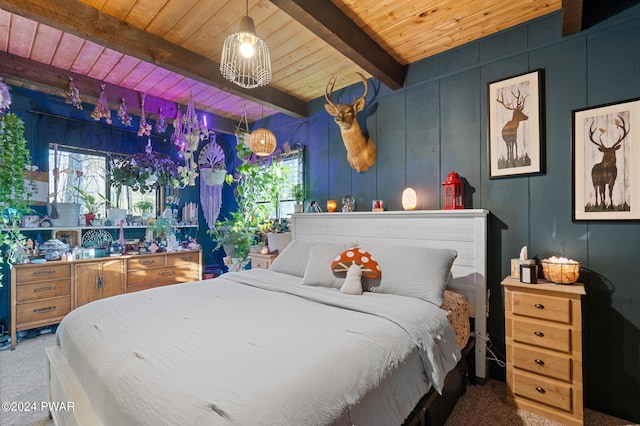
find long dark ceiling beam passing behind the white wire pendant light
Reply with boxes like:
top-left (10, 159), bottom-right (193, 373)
top-left (0, 0), bottom-right (307, 118)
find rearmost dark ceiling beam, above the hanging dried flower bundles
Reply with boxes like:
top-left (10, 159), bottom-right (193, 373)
top-left (0, 52), bottom-right (237, 133)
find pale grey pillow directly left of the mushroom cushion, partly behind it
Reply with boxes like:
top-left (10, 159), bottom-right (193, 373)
top-left (302, 243), bottom-right (355, 289)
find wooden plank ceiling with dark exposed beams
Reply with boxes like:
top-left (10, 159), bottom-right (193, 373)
top-left (0, 0), bottom-right (596, 130)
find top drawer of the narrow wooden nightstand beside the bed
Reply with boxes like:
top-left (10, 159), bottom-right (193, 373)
top-left (511, 291), bottom-right (571, 324)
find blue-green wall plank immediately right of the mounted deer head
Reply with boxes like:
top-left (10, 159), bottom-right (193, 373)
top-left (375, 92), bottom-right (407, 210)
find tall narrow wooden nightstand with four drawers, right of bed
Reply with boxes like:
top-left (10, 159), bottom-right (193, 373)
top-left (501, 277), bottom-right (586, 425)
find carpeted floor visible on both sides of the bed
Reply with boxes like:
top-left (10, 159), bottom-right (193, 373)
top-left (0, 334), bottom-right (633, 426)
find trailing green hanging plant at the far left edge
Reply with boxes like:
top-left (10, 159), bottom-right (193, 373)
top-left (0, 110), bottom-right (31, 278)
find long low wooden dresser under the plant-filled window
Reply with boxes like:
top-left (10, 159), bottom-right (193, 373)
top-left (10, 250), bottom-right (202, 349)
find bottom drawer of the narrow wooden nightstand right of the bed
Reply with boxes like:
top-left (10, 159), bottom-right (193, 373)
top-left (511, 372), bottom-right (572, 412)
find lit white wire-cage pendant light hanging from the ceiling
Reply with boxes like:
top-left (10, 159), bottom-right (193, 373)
top-left (220, 0), bottom-right (271, 89)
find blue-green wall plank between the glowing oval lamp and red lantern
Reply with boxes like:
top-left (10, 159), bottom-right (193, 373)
top-left (405, 83), bottom-right (440, 210)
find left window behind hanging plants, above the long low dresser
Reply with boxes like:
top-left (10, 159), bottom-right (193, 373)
top-left (49, 145), bottom-right (156, 217)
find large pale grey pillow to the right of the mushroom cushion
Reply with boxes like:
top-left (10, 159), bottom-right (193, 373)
top-left (362, 244), bottom-right (458, 306)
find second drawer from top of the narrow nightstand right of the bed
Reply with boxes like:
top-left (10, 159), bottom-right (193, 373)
top-left (508, 319), bottom-right (571, 353)
